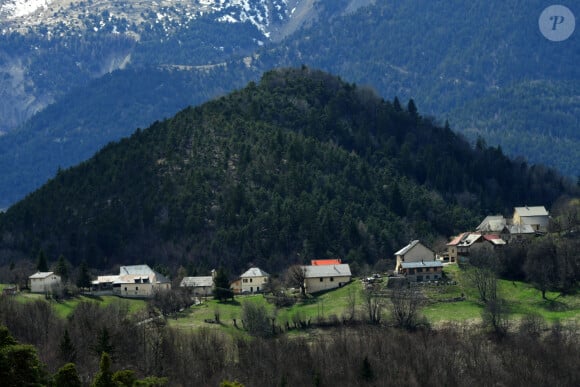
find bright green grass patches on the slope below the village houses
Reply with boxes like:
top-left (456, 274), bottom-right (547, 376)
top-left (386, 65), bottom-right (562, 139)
top-left (0, 265), bottom-right (580, 334)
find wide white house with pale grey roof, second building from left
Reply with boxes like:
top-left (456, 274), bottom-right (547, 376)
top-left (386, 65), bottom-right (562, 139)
top-left (92, 265), bottom-right (171, 298)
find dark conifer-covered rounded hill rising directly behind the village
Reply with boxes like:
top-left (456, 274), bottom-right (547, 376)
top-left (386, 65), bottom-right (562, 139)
top-left (0, 67), bottom-right (574, 271)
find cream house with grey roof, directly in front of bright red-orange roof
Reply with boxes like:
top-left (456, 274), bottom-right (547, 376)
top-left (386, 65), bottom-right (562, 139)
top-left (302, 263), bottom-right (352, 293)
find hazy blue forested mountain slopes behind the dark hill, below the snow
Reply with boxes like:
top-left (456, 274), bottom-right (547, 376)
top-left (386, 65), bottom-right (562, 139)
top-left (0, 0), bottom-right (580, 212)
